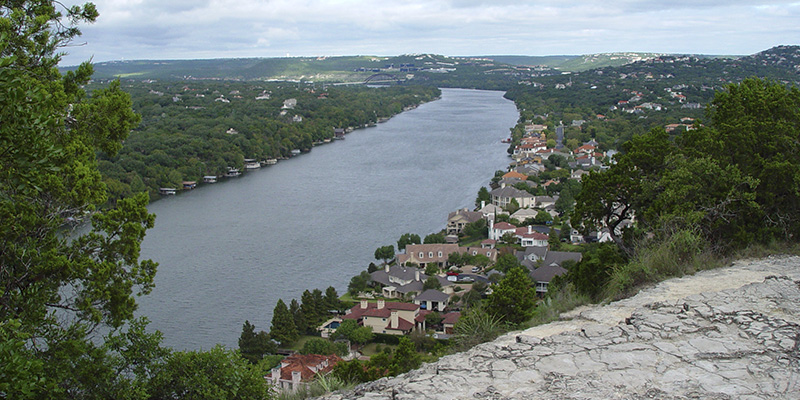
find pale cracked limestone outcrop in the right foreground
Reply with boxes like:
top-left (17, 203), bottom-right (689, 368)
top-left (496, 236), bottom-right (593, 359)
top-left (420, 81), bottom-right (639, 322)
top-left (320, 257), bottom-right (800, 400)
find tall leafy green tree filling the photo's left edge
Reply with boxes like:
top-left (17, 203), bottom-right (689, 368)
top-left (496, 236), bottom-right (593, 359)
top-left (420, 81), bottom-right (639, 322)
top-left (0, 1), bottom-right (166, 398)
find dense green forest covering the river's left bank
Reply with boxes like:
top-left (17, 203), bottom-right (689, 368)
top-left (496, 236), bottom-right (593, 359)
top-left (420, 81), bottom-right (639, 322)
top-left (93, 80), bottom-right (440, 202)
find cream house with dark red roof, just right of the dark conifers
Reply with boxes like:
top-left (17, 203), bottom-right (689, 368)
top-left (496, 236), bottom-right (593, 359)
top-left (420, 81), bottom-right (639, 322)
top-left (342, 300), bottom-right (419, 335)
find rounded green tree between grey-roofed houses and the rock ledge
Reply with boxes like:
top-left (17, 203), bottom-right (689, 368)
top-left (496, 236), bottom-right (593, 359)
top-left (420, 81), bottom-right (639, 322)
top-left (487, 266), bottom-right (536, 324)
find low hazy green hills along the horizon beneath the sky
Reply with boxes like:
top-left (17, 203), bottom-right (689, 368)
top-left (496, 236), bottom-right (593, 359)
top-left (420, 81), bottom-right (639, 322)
top-left (63, 46), bottom-right (797, 90)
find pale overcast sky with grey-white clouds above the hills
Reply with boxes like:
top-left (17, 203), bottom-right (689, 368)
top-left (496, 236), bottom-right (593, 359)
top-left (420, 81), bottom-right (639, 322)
top-left (62, 0), bottom-right (800, 65)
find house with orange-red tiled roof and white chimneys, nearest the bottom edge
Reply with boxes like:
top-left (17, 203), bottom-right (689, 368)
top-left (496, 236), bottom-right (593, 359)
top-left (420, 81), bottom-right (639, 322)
top-left (265, 354), bottom-right (342, 392)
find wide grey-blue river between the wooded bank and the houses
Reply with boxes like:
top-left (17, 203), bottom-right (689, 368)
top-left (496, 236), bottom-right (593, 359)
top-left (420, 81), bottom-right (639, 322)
top-left (138, 89), bottom-right (519, 350)
